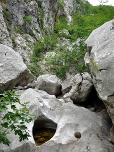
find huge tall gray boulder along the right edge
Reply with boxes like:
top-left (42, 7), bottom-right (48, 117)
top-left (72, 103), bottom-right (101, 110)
top-left (85, 20), bottom-right (114, 142)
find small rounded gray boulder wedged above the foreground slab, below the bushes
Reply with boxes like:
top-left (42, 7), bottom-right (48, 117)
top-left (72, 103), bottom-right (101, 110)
top-left (36, 74), bottom-right (61, 96)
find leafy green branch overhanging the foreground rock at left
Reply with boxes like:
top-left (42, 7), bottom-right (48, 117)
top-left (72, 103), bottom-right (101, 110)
top-left (0, 90), bottom-right (36, 146)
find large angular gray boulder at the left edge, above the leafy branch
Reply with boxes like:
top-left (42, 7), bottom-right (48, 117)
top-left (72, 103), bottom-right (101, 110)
top-left (0, 44), bottom-right (34, 92)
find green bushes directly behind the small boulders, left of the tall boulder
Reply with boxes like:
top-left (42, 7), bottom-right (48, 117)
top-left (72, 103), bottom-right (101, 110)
top-left (48, 40), bottom-right (87, 79)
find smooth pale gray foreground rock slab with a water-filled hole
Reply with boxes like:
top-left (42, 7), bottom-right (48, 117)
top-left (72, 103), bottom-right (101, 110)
top-left (0, 89), bottom-right (114, 152)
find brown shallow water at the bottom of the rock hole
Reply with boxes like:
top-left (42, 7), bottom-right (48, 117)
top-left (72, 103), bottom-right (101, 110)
top-left (33, 128), bottom-right (56, 146)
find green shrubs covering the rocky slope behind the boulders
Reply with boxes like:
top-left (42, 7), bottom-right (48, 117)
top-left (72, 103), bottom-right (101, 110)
top-left (29, 0), bottom-right (114, 79)
